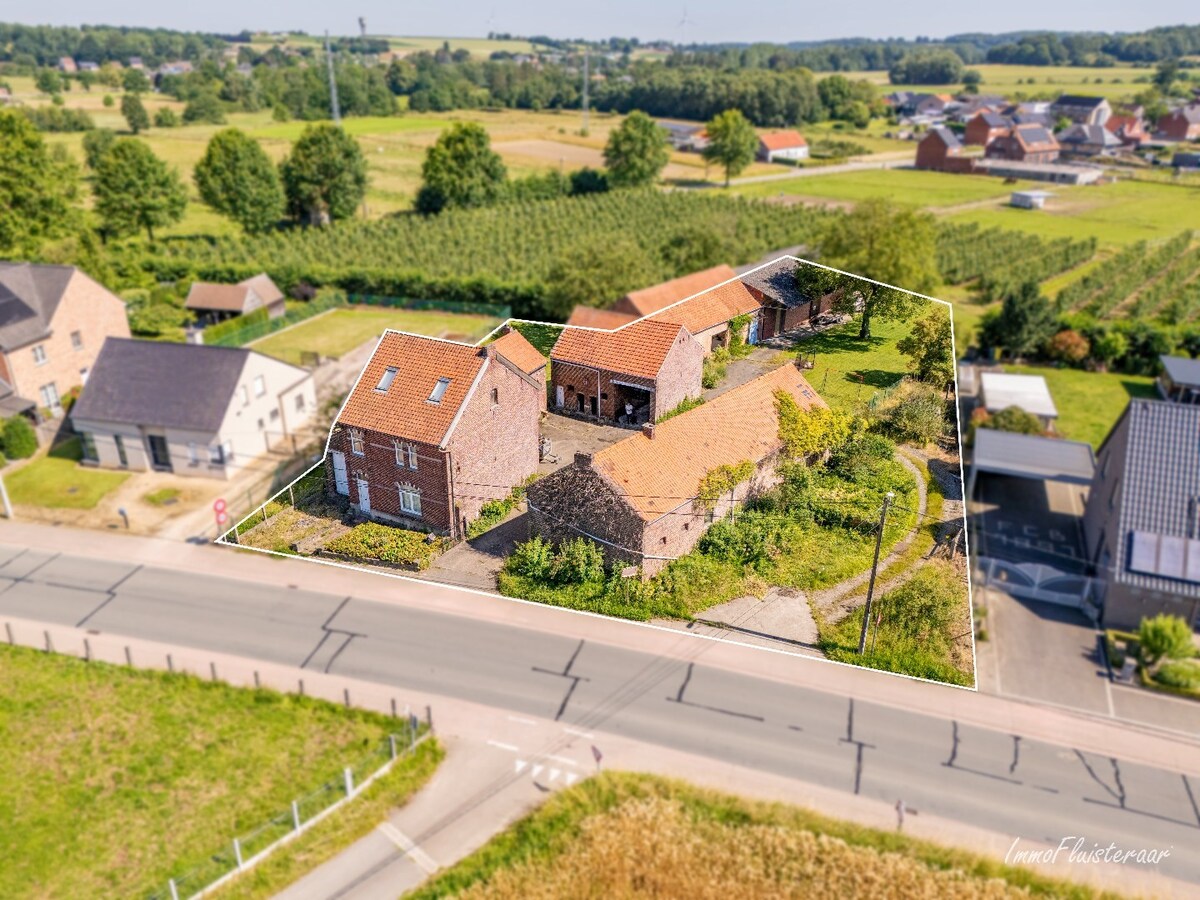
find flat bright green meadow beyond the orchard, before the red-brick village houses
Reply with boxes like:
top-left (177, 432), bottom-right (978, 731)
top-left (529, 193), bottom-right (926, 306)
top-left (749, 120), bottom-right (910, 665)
top-left (731, 168), bottom-right (1022, 206)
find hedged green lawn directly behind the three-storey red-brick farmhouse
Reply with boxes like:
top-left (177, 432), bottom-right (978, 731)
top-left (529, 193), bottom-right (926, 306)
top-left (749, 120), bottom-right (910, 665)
top-left (250, 306), bottom-right (500, 364)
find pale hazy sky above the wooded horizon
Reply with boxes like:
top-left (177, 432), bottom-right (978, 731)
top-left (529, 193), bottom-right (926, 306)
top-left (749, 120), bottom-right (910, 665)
top-left (11, 0), bottom-right (1200, 43)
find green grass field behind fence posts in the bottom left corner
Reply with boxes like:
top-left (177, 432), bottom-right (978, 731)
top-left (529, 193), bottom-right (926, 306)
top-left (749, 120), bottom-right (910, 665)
top-left (0, 647), bottom-right (436, 896)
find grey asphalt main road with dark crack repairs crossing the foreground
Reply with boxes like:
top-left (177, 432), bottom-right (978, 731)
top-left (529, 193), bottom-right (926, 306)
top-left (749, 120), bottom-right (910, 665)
top-left (7, 545), bottom-right (1200, 883)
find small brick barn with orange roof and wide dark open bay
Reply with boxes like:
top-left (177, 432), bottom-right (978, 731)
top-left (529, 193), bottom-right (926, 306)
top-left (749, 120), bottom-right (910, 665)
top-left (550, 320), bottom-right (704, 426)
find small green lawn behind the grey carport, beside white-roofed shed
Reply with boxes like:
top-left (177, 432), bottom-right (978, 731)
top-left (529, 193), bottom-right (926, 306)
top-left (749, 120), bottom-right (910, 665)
top-left (1004, 366), bottom-right (1158, 448)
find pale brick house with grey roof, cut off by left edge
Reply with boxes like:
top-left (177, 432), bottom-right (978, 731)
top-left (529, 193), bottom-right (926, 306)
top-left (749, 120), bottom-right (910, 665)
top-left (0, 263), bottom-right (130, 415)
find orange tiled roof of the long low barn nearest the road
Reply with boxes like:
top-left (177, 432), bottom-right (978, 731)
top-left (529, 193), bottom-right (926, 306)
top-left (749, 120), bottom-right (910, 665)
top-left (592, 365), bottom-right (826, 522)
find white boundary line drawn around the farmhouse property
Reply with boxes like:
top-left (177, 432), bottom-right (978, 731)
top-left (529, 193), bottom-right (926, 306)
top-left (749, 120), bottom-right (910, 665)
top-left (212, 254), bottom-right (979, 694)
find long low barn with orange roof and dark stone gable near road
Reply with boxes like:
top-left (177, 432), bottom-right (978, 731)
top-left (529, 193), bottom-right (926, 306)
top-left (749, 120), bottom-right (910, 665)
top-left (527, 364), bottom-right (824, 577)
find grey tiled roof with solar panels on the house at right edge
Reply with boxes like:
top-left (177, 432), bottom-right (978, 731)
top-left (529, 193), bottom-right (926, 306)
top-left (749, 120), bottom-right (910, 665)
top-left (1109, 400), bottom-right (1200, 598)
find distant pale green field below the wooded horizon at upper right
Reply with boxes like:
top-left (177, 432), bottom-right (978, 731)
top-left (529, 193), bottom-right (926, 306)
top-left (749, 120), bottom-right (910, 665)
top-left (818, 64), bottom-right (1154, 100)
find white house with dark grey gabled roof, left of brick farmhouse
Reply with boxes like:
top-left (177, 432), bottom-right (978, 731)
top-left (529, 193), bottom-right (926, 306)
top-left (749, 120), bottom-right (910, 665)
top-left (71, 337), bottom-right (317, 479)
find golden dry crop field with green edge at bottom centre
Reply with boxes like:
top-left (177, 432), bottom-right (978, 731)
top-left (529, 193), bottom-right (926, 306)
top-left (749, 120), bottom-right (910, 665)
top-left (407, 773), bottom-right (1098, 900)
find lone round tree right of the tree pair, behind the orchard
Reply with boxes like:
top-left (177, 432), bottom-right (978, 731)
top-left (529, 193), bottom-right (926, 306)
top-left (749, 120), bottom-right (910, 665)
top-left (416, 122), bottom-right (508, 212)
